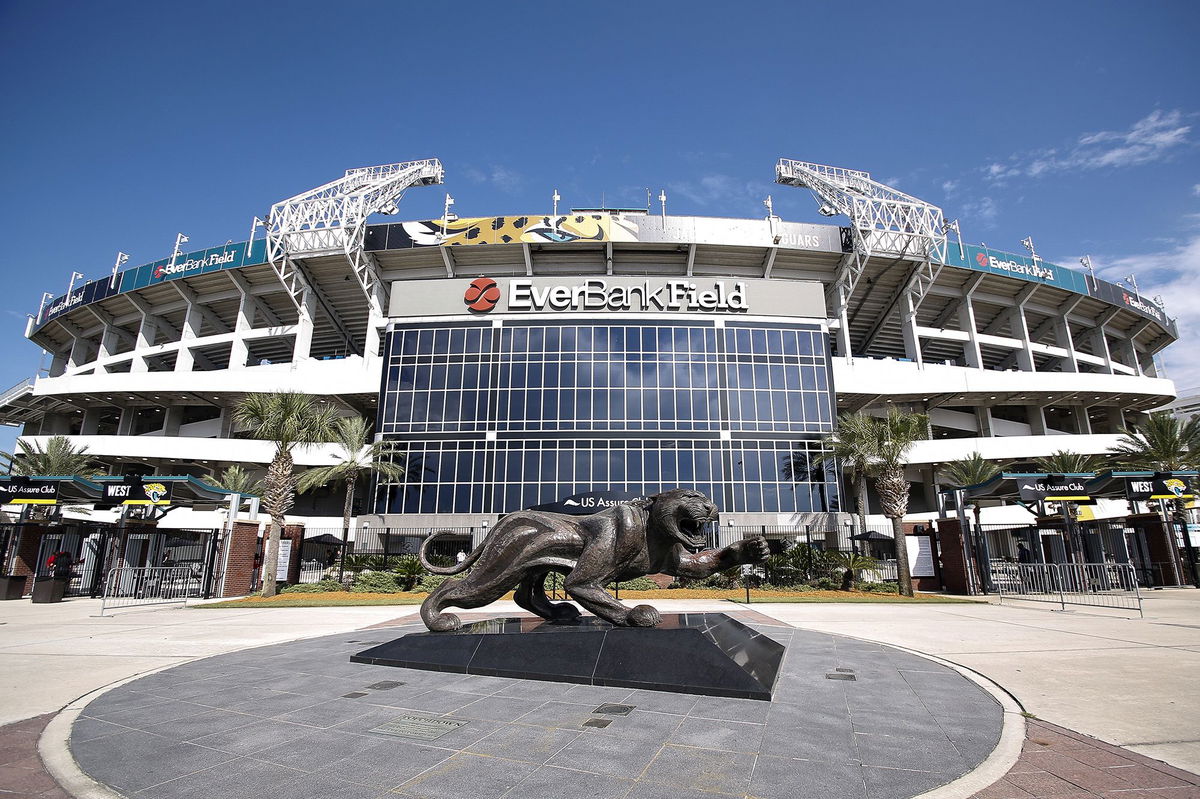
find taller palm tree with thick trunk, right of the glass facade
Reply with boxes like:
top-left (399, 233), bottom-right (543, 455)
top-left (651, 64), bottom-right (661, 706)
top-left (869, 408), bottom-right (929, 596)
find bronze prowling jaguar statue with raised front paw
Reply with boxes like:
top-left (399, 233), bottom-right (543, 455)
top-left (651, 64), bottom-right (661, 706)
top-left (420, 488), bottom-right (769, 632)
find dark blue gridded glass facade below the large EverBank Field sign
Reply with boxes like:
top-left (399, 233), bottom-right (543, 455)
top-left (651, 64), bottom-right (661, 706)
top-left (376, 318), bottom-right (838, 513)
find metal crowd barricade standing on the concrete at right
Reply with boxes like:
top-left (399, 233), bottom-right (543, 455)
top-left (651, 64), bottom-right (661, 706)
top-left (991, 563), bottom-right (1142, 615)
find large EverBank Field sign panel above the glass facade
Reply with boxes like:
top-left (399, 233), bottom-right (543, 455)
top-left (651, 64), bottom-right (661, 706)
top-left (390, 276), bottom-right (824, 319)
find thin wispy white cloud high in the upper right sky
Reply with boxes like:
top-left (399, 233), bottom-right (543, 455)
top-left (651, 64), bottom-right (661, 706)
top-left (983, 109), bottom-right (1192, 182)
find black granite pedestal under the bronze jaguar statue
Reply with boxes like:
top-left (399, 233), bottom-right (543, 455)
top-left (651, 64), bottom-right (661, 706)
top-left (350, 613), bottom-right (784, 701)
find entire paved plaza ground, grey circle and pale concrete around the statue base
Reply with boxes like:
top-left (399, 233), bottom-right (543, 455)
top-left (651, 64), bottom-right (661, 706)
top-left (0, 590), bottom-right (1200, 799)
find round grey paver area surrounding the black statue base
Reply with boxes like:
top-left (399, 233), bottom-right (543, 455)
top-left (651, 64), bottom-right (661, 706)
top-left (71, 625), bottom-right (1003, 799)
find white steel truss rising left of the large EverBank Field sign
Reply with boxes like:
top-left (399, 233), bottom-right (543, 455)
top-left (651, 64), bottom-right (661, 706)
top-left (266, 158), bottom-right (445, 308)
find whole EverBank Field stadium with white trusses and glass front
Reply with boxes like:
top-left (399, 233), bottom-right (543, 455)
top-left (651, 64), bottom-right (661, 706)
top-left (0, 160), bottom-right (1177, 585)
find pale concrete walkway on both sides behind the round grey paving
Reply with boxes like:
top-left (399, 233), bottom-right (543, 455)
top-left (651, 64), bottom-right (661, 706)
top-left (0, 589), bottom-right (1200, 773)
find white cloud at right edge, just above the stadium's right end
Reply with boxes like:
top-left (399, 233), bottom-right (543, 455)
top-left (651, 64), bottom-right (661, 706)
top-left (1092, 233), bottom-right (1200, 389)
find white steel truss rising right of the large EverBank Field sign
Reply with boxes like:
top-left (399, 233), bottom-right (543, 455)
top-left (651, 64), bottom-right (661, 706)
top-left (775, 158), bottom-right (946, 357)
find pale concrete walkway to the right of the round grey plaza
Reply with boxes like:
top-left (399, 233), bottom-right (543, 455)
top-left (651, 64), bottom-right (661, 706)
top-left (754, 589), bottom-right (1200, 774)
